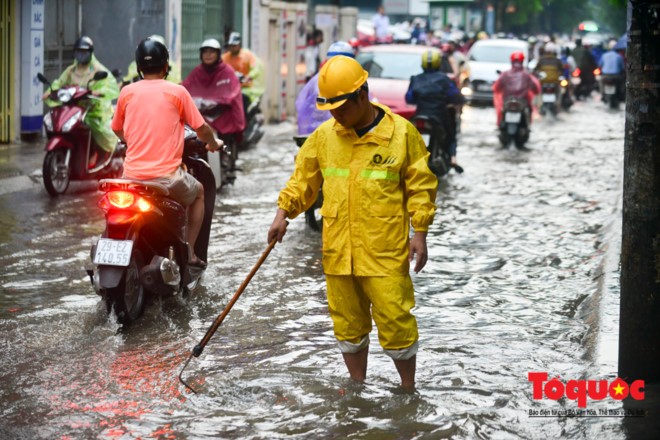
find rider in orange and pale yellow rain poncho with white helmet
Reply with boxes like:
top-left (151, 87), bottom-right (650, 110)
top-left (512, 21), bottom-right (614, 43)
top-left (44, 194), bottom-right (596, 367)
top-left (222, 32), bottom-right (264, 111)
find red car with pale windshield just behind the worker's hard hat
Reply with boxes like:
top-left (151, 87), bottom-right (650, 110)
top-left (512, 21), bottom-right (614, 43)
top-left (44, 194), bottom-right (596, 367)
top-left (356, 44), bottom-right (439, 119)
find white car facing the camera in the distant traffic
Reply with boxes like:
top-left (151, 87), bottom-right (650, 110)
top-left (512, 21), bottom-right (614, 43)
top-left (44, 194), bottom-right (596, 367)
top-left (461, 38), bottom-right (528, 104)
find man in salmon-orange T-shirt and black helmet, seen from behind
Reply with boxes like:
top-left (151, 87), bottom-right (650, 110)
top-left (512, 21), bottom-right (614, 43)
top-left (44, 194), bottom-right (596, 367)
top-left (112, 38), bottom-right (222, 267)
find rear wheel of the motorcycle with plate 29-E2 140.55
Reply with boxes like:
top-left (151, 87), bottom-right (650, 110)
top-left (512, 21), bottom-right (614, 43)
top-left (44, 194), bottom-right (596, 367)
top-left (105, 250), bottom-right (145, 325)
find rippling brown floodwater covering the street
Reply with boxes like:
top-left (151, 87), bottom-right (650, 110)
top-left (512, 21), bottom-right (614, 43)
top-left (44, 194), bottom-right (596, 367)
top-left (0, 100), bottom-right (634, 440)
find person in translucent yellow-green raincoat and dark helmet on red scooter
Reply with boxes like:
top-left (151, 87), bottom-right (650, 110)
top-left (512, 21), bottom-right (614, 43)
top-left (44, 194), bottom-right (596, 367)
top-left (43, 36), bottom-right (119, 166)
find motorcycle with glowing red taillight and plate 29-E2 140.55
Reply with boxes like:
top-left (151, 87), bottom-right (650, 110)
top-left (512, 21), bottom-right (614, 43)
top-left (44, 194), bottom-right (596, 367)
top-left (87, 127), bottom-right (215, 324)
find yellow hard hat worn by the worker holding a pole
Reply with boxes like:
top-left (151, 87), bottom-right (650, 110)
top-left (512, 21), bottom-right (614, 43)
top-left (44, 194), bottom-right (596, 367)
top-left (316, 55), bottom-right (369, 110)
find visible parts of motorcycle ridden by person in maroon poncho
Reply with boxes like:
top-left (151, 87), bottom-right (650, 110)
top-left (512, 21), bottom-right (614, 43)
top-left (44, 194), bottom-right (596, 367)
top-left (193, 97), bottom-right (239, 190)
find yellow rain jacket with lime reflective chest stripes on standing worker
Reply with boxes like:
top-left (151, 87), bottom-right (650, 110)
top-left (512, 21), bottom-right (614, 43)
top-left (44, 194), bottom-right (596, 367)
top-left (277, 103), bottom-right (438, 276)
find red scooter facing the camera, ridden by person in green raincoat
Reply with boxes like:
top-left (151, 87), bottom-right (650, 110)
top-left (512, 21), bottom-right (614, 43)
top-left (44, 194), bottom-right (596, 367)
top-left (37, 72), bottom-right (126, 197)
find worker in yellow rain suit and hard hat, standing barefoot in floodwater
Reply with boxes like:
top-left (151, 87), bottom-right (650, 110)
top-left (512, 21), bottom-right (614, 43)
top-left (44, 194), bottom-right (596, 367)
top-left (268, 56), bottom-right (438, 389)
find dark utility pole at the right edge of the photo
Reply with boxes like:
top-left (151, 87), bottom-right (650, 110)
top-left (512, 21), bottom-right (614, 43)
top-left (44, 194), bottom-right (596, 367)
top-left (619, 0), bottom-right (660, 384)
